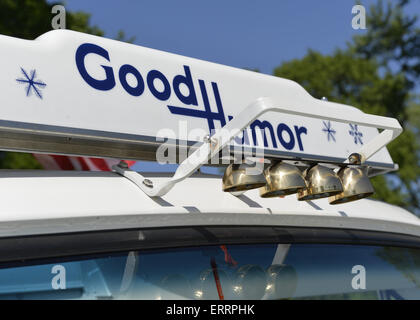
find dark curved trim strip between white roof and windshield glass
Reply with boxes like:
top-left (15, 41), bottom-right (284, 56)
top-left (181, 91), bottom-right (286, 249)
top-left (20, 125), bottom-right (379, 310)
top-left (0, 226), bottom-right (420, 264)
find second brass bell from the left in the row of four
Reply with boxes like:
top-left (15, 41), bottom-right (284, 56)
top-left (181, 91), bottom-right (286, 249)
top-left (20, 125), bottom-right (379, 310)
top-left (260, 162), bottom-right (306, 198)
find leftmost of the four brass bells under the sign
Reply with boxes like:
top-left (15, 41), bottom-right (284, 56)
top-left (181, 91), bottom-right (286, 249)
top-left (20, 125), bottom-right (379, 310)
top-left (223, 162), bottom-right (266, 192)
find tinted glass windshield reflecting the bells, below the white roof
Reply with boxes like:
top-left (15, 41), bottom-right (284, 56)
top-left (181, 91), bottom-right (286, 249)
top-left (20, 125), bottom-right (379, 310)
top-left (0, 243), bottom-right (420, 299)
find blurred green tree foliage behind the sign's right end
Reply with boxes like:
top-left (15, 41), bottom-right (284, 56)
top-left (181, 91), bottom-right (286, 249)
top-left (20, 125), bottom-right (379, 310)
top-left (274, 1), bottom-right (420, 212)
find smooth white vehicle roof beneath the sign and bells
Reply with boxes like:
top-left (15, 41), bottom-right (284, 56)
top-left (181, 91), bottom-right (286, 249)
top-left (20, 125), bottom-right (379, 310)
top-left (0, 170), bottom-right (420, 237)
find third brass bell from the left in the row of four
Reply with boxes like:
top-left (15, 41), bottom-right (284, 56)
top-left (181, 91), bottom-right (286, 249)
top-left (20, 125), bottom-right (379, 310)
top-left (298, 164), bottom-right (343, 201)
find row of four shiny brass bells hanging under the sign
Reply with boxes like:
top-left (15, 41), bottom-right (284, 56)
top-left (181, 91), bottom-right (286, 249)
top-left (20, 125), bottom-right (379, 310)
top-left (223, 154), bottom-right (374, 204)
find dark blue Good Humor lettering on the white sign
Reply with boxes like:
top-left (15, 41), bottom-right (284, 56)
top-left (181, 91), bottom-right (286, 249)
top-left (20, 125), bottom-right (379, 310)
top-left (76, 43), bottom-right (308, 151)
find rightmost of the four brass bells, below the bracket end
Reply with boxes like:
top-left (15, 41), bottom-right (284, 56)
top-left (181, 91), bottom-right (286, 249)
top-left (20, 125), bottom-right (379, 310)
top-left (329, 166), bottom-right (375, 204)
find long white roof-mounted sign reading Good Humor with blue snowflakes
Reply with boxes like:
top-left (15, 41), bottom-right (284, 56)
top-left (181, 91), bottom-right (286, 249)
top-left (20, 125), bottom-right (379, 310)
top-left (0, 30), bottom-right (396, 178)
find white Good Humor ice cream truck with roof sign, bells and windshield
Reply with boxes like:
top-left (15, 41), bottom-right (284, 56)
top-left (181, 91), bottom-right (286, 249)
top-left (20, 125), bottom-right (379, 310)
top-left (0, 30), bottom-right (420, 300)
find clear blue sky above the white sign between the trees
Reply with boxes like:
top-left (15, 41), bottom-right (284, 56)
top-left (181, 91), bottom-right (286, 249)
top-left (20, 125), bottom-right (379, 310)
top-left (61, 0), bottom-right (420, 74)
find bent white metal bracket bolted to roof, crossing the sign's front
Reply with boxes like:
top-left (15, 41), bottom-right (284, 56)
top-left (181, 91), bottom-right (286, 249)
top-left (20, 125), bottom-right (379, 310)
top-left (113, 97), bottom-right (402, 197)
